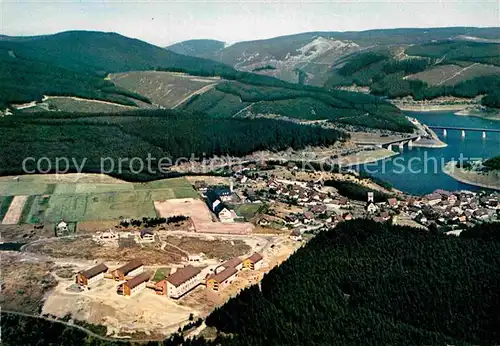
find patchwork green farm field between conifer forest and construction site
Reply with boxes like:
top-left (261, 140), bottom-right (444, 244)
top-left (0, 177), bottom-right (197, 223)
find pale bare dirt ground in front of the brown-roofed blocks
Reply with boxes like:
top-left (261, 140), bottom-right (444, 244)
top-left (42, 279), bottom-right (198, 336)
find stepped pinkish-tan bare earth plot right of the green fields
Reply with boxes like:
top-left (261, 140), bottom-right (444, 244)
top-left (154, 198), bottom-right (254, 234)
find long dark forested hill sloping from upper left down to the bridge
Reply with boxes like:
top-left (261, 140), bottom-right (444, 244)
top-left (0, 31), bottom-right (413, 132)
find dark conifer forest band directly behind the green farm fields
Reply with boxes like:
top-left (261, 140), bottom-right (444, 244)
top-left (0, 110), bottom-right (347, 180)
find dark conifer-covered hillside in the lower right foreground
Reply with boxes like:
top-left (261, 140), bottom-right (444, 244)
top-left (206, 220), bottom-right (500, 346)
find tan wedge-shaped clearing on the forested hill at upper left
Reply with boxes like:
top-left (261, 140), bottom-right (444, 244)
top-left (109, 71), bottom-right (220, 108)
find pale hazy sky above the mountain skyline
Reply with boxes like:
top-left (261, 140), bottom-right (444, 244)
top-left (0, 0), bottom-right (500, 46)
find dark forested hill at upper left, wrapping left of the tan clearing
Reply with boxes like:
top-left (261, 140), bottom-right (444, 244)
top-left (0, 31), bottom-right (234, 109)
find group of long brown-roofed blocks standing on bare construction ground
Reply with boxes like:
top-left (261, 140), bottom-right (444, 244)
top-left (76, 253), bottom-right (263, 299)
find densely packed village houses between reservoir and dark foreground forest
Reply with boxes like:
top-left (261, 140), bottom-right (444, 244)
top-left (201, 164), bottom-right (500, 237)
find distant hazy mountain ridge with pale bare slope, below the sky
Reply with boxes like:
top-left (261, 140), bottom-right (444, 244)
top-left (167, 27), bottom-right (500, 86)
